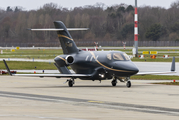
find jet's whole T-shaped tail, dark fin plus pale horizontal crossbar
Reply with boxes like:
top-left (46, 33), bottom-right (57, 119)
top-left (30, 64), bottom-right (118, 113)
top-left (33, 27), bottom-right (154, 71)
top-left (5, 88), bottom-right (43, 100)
top-left (29, 21), bottom-right (88, 54)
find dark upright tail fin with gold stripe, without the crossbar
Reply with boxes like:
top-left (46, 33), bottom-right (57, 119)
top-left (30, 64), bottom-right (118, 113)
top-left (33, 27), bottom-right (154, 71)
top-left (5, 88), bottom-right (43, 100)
top-left (54, 21), bottom-right (79, 54)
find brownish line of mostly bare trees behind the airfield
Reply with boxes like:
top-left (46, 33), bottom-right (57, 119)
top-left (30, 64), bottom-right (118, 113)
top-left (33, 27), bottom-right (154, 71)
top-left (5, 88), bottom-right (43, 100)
top-left (0, 1), bottom-right (179, 43)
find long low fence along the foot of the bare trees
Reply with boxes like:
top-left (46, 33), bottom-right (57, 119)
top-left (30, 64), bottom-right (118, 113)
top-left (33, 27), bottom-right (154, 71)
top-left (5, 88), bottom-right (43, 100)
top-left (0, 41), bottom-right (179, 47)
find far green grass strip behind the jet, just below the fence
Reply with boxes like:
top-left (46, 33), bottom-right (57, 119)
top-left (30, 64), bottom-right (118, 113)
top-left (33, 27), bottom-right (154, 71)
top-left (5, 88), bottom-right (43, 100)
top-left (0, 49), bottom-right (179, 62)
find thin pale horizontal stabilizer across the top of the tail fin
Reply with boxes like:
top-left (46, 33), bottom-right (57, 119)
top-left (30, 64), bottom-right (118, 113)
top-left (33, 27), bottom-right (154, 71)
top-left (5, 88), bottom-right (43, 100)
top-left (27, 28), bottom-right (89, 31)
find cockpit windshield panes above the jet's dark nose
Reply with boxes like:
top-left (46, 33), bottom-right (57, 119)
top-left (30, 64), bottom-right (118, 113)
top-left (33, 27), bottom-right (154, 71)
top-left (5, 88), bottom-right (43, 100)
top-left (107, 53), bottom-right (130, 61)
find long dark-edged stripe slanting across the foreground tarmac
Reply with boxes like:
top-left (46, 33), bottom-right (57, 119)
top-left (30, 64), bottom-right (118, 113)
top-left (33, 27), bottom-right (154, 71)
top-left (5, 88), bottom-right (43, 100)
top-left (0, 91), bottom-right (179, 116)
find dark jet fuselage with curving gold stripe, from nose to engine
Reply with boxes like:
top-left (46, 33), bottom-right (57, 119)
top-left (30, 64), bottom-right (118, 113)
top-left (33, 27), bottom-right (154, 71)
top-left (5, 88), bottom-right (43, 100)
top-left (55, 51), bottom-right (139, 80)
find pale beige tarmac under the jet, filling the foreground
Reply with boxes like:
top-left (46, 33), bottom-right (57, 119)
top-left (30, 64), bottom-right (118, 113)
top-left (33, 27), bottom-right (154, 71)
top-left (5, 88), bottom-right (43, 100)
top-left (0, 76), bottom-right (179, 120)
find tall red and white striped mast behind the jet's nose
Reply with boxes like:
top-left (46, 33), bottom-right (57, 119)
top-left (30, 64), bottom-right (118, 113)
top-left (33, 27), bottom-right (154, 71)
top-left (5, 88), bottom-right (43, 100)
top-left (134, 0), bottom-right (138, 57)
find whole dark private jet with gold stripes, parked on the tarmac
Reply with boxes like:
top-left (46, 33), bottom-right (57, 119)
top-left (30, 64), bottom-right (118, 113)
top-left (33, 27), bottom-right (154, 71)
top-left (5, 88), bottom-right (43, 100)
top-left (3, 21), bottom-right (175, 87)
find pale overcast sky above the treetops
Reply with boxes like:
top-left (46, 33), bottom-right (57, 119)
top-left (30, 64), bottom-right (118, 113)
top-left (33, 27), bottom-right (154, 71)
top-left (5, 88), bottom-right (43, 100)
top-left (0, 0), bottom-right (178, 10)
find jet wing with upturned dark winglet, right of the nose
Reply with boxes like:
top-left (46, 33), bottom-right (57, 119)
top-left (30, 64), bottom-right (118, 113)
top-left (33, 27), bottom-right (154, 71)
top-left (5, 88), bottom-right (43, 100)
top-left (136, 57), bottom-right (176, 75)
